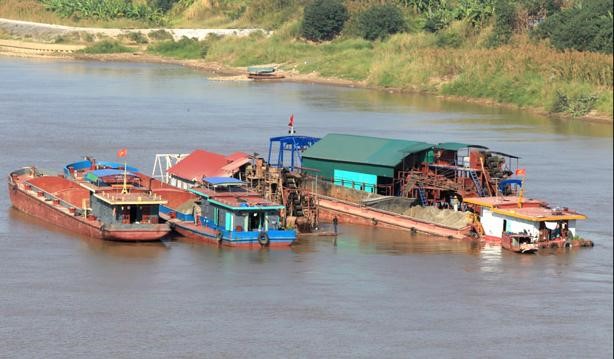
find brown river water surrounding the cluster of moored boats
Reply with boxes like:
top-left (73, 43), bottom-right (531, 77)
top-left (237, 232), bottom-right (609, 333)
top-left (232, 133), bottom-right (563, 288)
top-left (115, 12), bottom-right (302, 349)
top-left (0, 58), bottom-right (613, 358)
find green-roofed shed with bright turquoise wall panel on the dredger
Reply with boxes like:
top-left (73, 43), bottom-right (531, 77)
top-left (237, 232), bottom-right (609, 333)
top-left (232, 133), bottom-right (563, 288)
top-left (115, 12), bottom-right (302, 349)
top-left (302, 133), bottom-right (435, 192)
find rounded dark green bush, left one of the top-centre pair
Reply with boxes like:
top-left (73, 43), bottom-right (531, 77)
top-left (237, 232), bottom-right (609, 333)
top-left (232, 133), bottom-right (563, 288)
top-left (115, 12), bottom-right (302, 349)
top-left (302, 0), bottom-right (348, 41)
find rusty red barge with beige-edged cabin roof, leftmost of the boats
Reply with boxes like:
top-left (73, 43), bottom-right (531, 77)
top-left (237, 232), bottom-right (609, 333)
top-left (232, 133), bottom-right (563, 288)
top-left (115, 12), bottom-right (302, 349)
top-left (8, 161), bottom-right (170, 241)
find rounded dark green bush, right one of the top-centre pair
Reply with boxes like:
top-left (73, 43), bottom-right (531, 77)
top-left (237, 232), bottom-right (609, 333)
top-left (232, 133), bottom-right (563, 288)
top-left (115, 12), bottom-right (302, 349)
top-left (358, 4), bottom-right (405, 40)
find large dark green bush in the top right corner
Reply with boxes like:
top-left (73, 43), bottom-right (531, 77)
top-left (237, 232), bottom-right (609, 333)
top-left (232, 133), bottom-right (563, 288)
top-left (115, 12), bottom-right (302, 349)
top-left (532, 0), bottom-right (613, 54)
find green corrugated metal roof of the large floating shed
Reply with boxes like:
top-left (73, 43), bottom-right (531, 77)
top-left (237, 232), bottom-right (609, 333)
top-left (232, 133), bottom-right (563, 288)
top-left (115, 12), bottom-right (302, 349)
top-left (303, 133), bottom-right (434, 167)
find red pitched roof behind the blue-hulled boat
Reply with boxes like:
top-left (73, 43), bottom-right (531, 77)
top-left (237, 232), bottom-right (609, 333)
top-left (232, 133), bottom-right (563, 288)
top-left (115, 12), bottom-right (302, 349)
top-left (168, 150), bottom-right (249, 181)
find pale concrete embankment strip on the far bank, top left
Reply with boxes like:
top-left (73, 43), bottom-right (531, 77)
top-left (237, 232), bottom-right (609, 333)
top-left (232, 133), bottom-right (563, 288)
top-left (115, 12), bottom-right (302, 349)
top-left (0, 18), bottom-right (268, 41)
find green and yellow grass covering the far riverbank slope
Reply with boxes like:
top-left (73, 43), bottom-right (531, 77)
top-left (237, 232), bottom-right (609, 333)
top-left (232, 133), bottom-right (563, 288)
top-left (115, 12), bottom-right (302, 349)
top-left (0, 0), bottom-right (614, 121)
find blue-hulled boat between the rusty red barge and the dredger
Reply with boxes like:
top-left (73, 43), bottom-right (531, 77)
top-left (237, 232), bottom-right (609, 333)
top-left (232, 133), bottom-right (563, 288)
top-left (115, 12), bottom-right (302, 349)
top-left (151, 177), bottom-right (296, 248)
